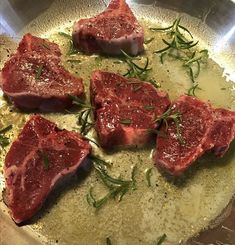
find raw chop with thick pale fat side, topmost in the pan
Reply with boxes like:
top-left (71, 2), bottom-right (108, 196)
top-left (72, 0), bottom-right (144, 55)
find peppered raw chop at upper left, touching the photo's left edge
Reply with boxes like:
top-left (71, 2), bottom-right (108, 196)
top-left (0, 34), bottom-right (84, 112)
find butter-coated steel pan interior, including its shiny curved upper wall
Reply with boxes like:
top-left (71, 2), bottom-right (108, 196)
top-left (0, 1), bottom-right (235, 245)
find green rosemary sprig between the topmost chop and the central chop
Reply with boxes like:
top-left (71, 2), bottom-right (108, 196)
top-left (122, 50), bottom-right (152, 81)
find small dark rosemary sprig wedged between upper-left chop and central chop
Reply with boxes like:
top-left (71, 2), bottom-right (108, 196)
top-left (69, 95), bottom-right (94, 136)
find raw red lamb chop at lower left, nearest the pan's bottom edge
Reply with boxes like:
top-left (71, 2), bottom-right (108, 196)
top-left (4, 116), bottom-right (91, 223)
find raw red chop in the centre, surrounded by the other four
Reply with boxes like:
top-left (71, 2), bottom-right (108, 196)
top-left (90, 71), bottom-right (170, 149)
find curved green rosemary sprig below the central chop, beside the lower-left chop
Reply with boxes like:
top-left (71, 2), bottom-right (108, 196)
top-left (87, 157), bottom-right (136, 209)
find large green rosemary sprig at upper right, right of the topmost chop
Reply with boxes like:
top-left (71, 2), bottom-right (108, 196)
top-left (150, 18), bottom-right (208, 91)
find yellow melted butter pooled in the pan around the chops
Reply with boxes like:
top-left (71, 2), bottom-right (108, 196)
top-left (0, 21), bottom-right (235, 245)
